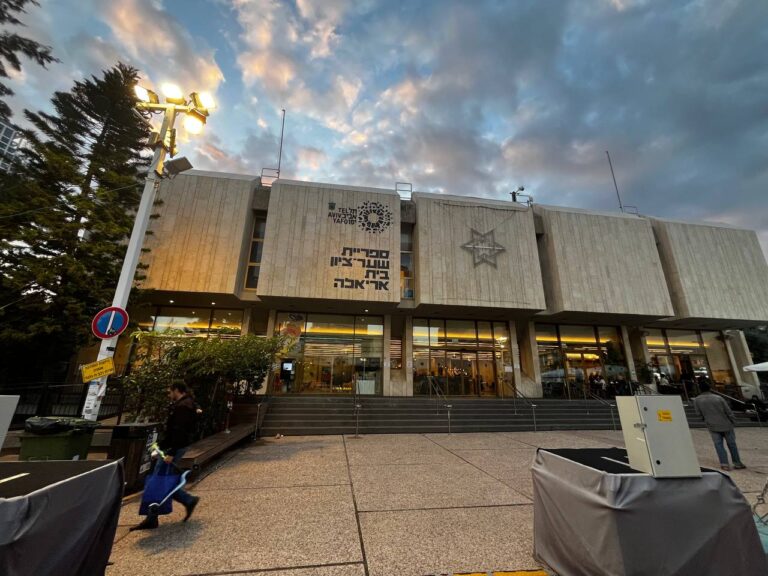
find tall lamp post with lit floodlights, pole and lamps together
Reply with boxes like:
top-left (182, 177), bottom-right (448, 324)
top-left (83, 84), bottom-right (215, 420)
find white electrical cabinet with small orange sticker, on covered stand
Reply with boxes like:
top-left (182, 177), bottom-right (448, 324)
top-left (616, 395), bottom-right (701, 478)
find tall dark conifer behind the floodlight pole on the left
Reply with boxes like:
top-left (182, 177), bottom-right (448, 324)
top-left (0, 64), bottom-right (149, 381)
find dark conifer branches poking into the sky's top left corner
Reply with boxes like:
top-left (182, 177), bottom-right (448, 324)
top-left (0, 0), bottom-right (58, 120)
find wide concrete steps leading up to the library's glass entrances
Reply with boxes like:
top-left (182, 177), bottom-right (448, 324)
top-left (261, 396), bottom-right (757, 436)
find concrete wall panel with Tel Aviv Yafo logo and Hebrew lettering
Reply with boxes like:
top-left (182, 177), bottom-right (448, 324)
top-left (258, 180), bottom-right (400, 303)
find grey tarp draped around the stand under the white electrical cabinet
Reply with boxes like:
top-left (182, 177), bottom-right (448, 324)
top-left (532, 449), bottom-right (768, 576)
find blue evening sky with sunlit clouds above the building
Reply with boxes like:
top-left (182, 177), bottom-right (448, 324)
top-left (8, 0), bottom-right (768, 253)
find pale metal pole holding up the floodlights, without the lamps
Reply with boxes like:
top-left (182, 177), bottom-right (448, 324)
top-left (83, 104), bottom-right (176, 420)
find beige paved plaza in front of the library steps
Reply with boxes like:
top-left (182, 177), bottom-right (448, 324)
top-left (107, 428), bottom-right (768, 576)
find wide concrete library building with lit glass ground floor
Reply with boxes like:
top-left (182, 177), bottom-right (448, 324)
top-left (133, 171), bottom-right (768, 398)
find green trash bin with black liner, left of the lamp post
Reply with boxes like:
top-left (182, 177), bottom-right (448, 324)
top-left (19, 416), bottom-right (99, 460)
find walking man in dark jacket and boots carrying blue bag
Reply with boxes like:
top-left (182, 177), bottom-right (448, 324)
top-left (131, 380), bottom-right (200, 530)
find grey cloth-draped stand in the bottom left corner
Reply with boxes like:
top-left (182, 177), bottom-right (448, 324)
top-left (0, 461), bottom-right (123, 576)
